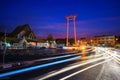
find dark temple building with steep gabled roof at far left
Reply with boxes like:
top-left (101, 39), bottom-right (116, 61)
top-left (0, 24), bottom-right (37, 48)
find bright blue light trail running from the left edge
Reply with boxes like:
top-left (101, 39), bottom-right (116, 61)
top-left (0, 56), bottom-right (81, 78)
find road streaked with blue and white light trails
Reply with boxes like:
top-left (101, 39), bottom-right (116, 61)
top-left (0, 47), bottom-right (120, 80)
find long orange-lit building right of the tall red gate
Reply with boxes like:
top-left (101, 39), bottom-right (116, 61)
top-left (77, 35), bottom-right (118, 47)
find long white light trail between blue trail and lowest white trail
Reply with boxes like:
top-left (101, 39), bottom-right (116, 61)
top-left (37, 57), bottom-right (110, 80)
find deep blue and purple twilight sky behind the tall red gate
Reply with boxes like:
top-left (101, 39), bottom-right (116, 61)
top-left (0, 0), bottom-right (120, 38)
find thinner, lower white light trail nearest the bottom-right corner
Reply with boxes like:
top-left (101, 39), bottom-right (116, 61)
top-left (60, 59), bottom-right (111, 80)
